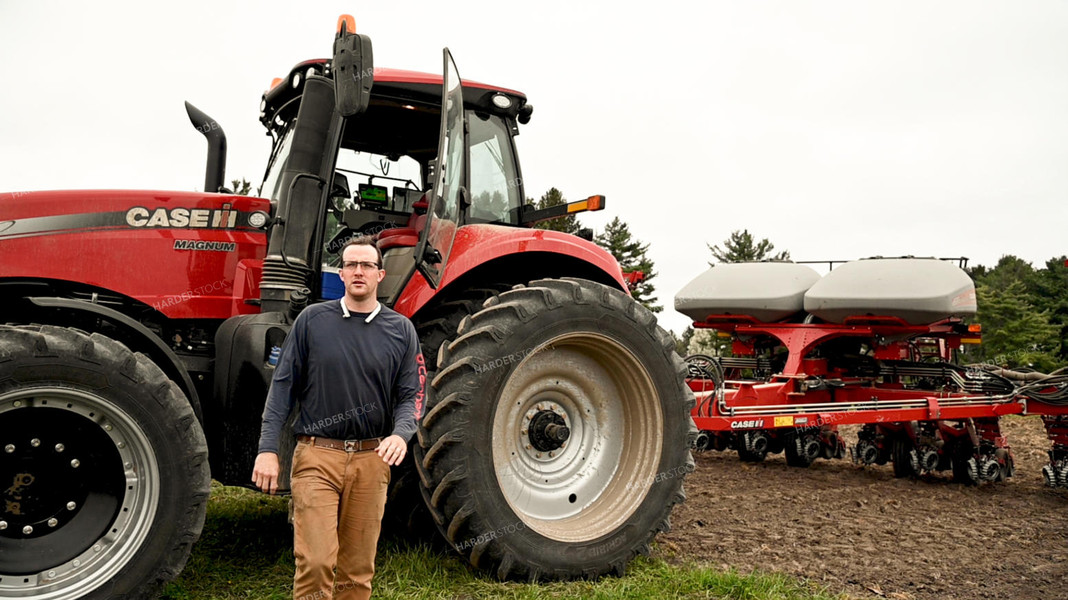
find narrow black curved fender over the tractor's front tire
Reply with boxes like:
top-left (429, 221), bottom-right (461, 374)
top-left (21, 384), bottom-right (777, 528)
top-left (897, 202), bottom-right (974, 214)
top-left (27, 297), bottom-right (204, 426)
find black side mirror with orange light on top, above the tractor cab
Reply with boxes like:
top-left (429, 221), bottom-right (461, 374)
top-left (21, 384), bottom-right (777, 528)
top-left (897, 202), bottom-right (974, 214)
top-left (331, 15), bottom-right (375, 116)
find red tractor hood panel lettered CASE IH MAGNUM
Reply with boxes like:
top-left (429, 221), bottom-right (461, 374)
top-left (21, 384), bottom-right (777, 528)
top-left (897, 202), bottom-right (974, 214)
top-left (0, 190), bottom-right (270, 318)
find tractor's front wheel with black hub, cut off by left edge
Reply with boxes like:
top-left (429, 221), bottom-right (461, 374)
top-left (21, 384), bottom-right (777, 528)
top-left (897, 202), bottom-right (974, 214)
top-left (0, 326), bottom-right (210, 600)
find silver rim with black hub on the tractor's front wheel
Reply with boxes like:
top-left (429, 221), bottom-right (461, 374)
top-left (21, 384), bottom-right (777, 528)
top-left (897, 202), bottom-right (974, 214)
top-left (0, 388), bottom-right (160, 600)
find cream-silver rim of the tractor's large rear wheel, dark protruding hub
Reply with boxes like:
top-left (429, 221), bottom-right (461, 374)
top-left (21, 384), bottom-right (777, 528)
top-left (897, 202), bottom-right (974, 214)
top-left (492, 333), bottom-right (657, 542)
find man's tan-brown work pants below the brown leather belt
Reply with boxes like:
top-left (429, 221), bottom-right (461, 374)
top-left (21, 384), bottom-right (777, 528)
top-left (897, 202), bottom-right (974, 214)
top-left (292, 443), bottom-right (390, 600)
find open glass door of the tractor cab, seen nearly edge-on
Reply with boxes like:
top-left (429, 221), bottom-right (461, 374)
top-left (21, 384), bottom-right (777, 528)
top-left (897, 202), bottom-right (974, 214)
top-left (415, 48), bottom-right (468, 288)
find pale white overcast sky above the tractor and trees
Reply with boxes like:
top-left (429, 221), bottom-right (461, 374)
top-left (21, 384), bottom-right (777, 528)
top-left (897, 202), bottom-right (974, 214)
top-left (0, 0), bottom-right (1068, 331)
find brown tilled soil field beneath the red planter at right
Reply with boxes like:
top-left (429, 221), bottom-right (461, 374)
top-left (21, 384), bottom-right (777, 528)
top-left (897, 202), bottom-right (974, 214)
top-left (658, 416), bottom-right (1068, 600)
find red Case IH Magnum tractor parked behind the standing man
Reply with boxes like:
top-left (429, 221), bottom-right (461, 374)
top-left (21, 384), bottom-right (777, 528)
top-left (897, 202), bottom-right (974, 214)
top-left (0, 17), bottom-right (696, 599)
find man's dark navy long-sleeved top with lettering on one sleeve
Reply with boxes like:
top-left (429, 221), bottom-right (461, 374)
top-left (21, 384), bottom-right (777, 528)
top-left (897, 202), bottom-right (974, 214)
top-left (260, 299), bottom-right (426, 453)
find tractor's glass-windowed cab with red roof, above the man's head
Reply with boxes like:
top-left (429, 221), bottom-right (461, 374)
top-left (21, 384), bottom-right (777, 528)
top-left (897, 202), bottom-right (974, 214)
top-left (260, 51), bottom-right (532, 304)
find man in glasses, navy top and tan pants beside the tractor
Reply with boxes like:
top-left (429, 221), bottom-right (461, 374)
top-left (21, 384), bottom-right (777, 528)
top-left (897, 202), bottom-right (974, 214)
top-left (252, 237), bottom-right (426, 600)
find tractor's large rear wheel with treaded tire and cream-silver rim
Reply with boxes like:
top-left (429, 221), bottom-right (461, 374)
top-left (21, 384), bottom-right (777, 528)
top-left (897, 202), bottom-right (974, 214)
top-left (414, 279), bottom-right (696, 581)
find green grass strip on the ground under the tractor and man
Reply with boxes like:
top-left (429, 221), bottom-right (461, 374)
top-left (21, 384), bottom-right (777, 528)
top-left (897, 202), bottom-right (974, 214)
top-left (163, 484), bottom-right (836, 600)
